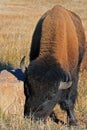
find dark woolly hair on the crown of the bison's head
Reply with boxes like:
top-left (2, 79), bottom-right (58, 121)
top-left (28, 56), bottom-right (68, 86)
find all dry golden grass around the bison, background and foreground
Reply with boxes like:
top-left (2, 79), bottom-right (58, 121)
top-left (0, 0), bottom-right (87, 130)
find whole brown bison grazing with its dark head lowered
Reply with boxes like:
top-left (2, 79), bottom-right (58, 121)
top-left (21, 5), bottom-right (86, 125)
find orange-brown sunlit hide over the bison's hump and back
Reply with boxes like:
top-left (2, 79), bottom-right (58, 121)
top-left (39, 6), bottom-right (84, 73)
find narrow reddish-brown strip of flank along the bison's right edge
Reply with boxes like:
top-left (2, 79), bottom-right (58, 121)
top-left (70, 12), bottom-right (86, 64)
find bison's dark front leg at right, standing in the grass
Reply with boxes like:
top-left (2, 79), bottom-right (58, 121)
top-left (60, 73), bottom-right (78, 126)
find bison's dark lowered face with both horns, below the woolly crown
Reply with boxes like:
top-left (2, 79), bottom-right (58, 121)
top-left (21, 57), bottom-right (72, 119)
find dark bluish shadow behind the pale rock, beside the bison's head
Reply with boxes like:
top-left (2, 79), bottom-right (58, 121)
top-left (0, 63), bottom-right (24, 81)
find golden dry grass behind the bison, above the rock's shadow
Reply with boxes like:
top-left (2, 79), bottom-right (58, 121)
top-left (0, 0), bottom-right (87, 67)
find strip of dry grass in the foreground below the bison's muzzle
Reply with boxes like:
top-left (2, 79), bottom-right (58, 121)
top-left (0, 115), bottom-right (86, 130)
